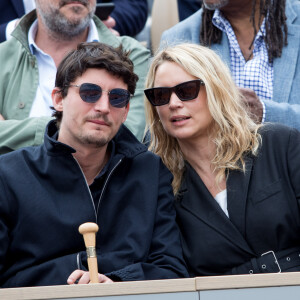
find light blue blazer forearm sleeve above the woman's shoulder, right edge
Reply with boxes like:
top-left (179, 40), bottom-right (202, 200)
top-left (263, 100), bottom-right (300, 130)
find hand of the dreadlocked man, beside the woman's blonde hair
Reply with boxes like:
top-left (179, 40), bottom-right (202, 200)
top-left (238, 87), bottom-right (263, 123)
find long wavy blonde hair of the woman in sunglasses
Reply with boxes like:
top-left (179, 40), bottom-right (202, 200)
top-left (145, 44), bottom-right (260, 194)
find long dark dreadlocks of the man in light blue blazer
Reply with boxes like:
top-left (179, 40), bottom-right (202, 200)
top-left (200, 0), bottom-right (287, 62)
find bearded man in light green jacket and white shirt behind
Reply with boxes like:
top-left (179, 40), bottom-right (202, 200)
top-left (0, 0), bottom-right (150, 154)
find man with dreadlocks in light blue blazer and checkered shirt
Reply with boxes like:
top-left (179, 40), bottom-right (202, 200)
top-left (161, 0), bottom-right (300, 130)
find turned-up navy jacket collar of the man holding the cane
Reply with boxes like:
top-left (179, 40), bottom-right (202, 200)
top-left (44, 120), bottom-right (147, 158)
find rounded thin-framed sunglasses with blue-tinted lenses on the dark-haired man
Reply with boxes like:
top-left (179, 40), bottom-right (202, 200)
top-left (67, 83), bottom-right (131, 108)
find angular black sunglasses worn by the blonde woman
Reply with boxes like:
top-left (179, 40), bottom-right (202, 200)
top-left (144, 79), bottom-right (204, 106)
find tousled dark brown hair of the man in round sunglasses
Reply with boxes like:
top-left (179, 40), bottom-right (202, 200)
top-left (53, 42), bottom-right (138, 126)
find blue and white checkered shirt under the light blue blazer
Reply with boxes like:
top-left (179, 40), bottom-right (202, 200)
top-left (213, 10), bottom-right (273, 120)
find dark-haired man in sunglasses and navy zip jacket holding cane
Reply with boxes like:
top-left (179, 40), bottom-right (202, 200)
top-left (0, 42), bottom-right (187, 287)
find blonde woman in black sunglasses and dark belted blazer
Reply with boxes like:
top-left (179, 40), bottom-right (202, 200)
top-left (145, 44), bottom-right (300, 276)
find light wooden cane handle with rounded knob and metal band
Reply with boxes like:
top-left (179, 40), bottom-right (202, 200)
top-left (78, 222), bottom-right (99, 283)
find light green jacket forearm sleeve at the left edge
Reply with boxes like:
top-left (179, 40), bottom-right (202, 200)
top-left (0, 117), bottom-right (51, 154)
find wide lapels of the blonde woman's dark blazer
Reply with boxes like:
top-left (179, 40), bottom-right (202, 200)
top-left (176, 158), bottom-right (252, 254)
